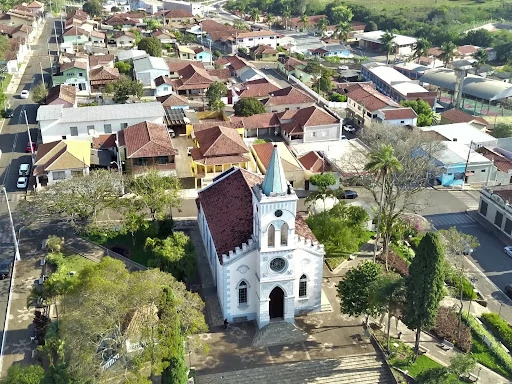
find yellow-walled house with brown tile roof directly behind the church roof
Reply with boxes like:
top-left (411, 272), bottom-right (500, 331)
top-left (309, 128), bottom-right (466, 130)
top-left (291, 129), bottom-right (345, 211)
top-left (191, 126), bottom-right (251, 188)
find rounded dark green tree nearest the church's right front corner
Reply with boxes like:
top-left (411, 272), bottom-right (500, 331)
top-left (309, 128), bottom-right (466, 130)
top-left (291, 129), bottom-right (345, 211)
top-left (338, 261), bottom-right (381, 324)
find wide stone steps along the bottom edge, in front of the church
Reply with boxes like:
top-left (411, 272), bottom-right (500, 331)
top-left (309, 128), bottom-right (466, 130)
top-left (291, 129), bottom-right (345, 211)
top-left (195, 354), bottom-right (396, 384)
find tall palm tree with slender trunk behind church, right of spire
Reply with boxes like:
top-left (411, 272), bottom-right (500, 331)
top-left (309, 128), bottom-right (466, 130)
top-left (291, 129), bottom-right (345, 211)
top-left (364, 144), bottom-right (402, 270)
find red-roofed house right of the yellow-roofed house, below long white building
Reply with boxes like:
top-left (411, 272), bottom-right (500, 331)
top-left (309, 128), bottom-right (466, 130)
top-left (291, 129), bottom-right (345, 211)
top-left (117, 121), bottom-right (178, 175)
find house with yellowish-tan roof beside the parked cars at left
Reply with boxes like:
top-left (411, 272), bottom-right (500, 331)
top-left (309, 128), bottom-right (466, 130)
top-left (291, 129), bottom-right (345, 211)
top-left (32, 140), bottom-right (91, 187)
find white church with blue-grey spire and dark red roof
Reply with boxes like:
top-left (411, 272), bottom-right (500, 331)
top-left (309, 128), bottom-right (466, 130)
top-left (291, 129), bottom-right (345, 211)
top-left (196, 146), bottom-right (324, 328)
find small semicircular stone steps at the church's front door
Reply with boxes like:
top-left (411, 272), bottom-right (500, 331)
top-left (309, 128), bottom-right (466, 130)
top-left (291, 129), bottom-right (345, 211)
top-left (252, 321), bottom-right (309, 347)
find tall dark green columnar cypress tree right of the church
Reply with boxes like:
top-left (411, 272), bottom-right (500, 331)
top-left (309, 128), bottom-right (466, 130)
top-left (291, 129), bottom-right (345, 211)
top-left (403, 232), bottom-right (444, 359)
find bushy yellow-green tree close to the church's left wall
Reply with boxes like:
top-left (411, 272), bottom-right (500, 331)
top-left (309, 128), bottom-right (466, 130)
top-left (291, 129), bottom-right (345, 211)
top-left (145, 232), bottom-right (196, 281)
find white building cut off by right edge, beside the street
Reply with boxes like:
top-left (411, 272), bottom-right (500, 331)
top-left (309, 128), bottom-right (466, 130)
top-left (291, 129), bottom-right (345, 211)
top-left (478, 185), bottom-right (512, 238)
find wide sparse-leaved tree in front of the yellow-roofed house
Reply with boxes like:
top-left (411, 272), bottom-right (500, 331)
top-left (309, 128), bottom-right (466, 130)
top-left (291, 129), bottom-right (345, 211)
top-left (17, 170), bottom-right (123, 232)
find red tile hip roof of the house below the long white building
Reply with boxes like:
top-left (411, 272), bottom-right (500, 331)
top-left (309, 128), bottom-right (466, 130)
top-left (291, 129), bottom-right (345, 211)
top-left (123, 121), bottom-right (178, 159)
